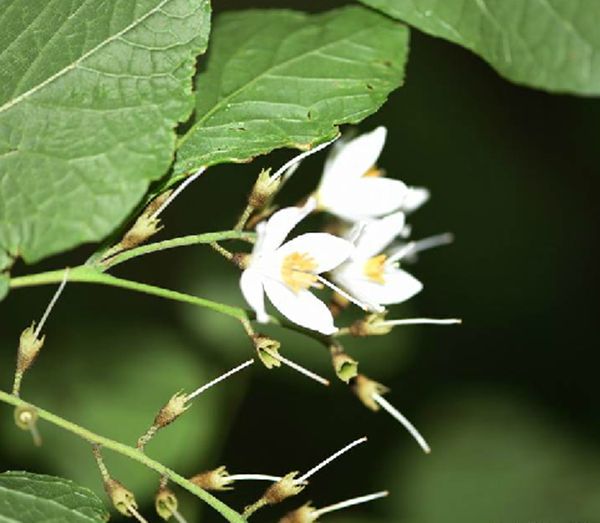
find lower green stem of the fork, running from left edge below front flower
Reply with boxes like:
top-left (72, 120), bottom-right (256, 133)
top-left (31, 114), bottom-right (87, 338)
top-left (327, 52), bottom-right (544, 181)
top-left (10, 265), bottom-right (248, 320)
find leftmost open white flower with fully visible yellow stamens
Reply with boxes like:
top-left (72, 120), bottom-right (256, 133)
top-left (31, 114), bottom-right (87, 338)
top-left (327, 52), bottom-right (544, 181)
top-left (240, 198), bottom-right (353, 335)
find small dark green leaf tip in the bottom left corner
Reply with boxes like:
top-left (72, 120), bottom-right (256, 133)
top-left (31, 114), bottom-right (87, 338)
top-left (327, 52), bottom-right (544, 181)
top-left (0, 472), bottom-right (109, 523)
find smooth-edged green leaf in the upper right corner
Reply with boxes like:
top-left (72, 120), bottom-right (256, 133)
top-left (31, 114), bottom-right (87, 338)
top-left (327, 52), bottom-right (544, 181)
top-left (360, 0), bottom-right (600, 95)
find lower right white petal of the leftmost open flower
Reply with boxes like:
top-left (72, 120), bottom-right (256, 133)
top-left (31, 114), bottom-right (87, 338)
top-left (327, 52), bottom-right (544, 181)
top-left (263, 279), bottom-right (337, 335)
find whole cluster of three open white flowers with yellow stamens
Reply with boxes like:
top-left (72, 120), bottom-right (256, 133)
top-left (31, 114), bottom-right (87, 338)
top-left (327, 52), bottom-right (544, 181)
top-left (240, 127), bottom-right (442, 335)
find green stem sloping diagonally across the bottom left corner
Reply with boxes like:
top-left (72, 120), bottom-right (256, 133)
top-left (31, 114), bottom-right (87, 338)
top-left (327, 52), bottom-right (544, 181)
top-left (0, 390), bottom-right (246, 523)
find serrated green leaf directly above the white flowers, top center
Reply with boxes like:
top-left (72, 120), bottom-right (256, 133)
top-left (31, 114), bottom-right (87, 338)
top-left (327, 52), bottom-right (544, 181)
top-left (175, 7), bottom-right (408, 174)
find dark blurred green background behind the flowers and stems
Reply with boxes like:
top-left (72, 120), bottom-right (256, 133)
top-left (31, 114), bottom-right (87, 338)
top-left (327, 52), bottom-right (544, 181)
top-left (0, 1), bottom-right (600, 523)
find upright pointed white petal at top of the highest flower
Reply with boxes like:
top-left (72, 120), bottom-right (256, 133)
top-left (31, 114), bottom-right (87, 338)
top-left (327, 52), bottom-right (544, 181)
top-left (321, 127), bottom-right (387, 191)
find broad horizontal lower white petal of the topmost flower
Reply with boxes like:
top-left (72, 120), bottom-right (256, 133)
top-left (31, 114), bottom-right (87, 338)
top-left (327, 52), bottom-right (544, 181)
top-left (319, 177), bottom-right (406, 222)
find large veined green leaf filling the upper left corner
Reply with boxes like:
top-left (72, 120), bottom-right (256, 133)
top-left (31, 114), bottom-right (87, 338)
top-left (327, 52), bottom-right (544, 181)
top-left (0, 0), bottom-right (210, 262)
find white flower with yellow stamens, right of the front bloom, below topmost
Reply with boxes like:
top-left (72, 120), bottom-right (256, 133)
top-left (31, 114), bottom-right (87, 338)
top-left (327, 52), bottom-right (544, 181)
top-left (332, 212), bottom-right (423, 311)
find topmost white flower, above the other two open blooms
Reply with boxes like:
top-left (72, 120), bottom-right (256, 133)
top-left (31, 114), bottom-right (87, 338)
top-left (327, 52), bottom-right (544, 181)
top-left (315, 127), bottom-right (429, 222)
